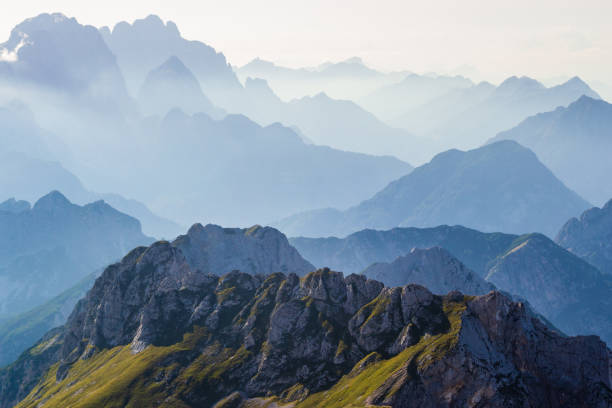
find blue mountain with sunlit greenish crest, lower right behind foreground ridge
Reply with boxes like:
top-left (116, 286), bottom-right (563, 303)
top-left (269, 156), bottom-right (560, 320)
top-left (486, 234), bottom-right (612, 344)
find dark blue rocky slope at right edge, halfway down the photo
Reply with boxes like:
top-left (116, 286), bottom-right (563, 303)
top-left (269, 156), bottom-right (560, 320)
top-left (555, 200), bottom-right (612, 274)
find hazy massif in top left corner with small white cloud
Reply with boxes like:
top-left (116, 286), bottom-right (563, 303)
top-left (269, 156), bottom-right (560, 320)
top-left (0, 13), bottom-right (128, 109)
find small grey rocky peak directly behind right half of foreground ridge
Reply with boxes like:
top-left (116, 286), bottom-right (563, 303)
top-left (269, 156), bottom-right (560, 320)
top-left (363, 247), bottom-right (495, 295)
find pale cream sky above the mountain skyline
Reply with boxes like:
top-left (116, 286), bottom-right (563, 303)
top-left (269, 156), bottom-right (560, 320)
top-left (0, 0), bottom-right (612, 85)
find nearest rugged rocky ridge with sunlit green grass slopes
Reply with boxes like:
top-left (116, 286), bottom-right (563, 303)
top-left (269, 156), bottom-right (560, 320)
top-left (0, 242), bottom-right (612, 408)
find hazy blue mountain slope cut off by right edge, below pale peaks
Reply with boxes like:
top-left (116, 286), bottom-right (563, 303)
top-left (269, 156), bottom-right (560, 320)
top-left (492, 96), bottom-right (612, 204)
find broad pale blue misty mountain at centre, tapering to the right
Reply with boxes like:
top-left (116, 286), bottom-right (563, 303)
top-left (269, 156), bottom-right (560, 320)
top-left (122, 110), bottom-right (412, 226)
